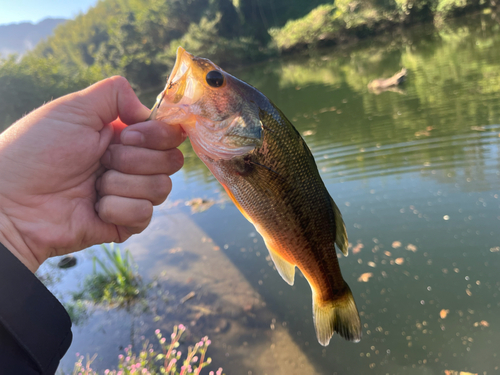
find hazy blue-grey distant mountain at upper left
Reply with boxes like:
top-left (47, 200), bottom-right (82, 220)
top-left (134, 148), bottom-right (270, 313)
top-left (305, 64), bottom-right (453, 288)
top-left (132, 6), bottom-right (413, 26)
top-left (0, 18), bottom-right (66, 56)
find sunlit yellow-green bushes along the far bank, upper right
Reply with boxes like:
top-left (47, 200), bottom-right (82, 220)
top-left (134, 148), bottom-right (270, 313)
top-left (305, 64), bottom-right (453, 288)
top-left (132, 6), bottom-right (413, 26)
top-left (269, 0), bottom-right (493, 51)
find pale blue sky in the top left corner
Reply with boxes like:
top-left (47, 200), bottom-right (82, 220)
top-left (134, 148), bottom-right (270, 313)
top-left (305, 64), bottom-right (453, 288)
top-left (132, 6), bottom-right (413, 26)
top-left (0, 0), bottom-right (97, 25)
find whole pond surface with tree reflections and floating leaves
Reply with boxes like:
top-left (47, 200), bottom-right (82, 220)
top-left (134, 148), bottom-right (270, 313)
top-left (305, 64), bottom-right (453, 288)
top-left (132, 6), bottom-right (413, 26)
top-left (50, 14), bottom-right (500, 374)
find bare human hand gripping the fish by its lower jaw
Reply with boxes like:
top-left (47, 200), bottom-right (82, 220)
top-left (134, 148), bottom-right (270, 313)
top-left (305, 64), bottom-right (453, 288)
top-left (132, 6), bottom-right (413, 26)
top-left (0, 77), bottom-right (185, 272)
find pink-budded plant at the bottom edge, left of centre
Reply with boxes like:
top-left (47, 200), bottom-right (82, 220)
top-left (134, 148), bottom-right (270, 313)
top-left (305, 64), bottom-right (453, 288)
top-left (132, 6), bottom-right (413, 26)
top-left (73, 324), bottom-right (223, 375)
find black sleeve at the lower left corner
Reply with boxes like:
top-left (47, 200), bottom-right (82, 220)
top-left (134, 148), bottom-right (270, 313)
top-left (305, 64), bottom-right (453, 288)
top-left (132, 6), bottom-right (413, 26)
top-left (0, 244), bottom-right (73, 375)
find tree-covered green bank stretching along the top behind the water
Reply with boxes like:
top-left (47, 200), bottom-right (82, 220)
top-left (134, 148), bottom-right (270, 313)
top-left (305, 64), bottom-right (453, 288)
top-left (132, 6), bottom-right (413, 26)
top-left (0, 0), bottom-right (495, 128)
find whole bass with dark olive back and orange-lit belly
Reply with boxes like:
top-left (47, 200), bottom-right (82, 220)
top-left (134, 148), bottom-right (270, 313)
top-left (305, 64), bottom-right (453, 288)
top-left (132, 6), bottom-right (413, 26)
top-left (150, 47), bottom-right (362, 346)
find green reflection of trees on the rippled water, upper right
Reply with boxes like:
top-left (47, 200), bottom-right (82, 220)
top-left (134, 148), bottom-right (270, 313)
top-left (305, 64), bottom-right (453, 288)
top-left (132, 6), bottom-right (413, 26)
top-left (224, 13), bottom-right (500, 190)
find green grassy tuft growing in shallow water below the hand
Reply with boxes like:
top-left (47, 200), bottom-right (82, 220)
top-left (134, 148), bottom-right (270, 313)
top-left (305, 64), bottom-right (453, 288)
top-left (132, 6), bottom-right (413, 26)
top-left (79, 244), bottom-right (143, 306)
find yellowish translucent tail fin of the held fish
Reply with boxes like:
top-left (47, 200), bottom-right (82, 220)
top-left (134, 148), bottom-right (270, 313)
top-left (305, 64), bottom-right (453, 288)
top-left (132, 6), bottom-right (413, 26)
top-left (313, 284), bottom-right (362, 346)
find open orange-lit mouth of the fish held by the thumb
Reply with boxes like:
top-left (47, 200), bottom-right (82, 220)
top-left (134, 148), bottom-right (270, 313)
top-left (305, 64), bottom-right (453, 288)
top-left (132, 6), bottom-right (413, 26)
top-left (148, 46), bottom-right (203, 120)
